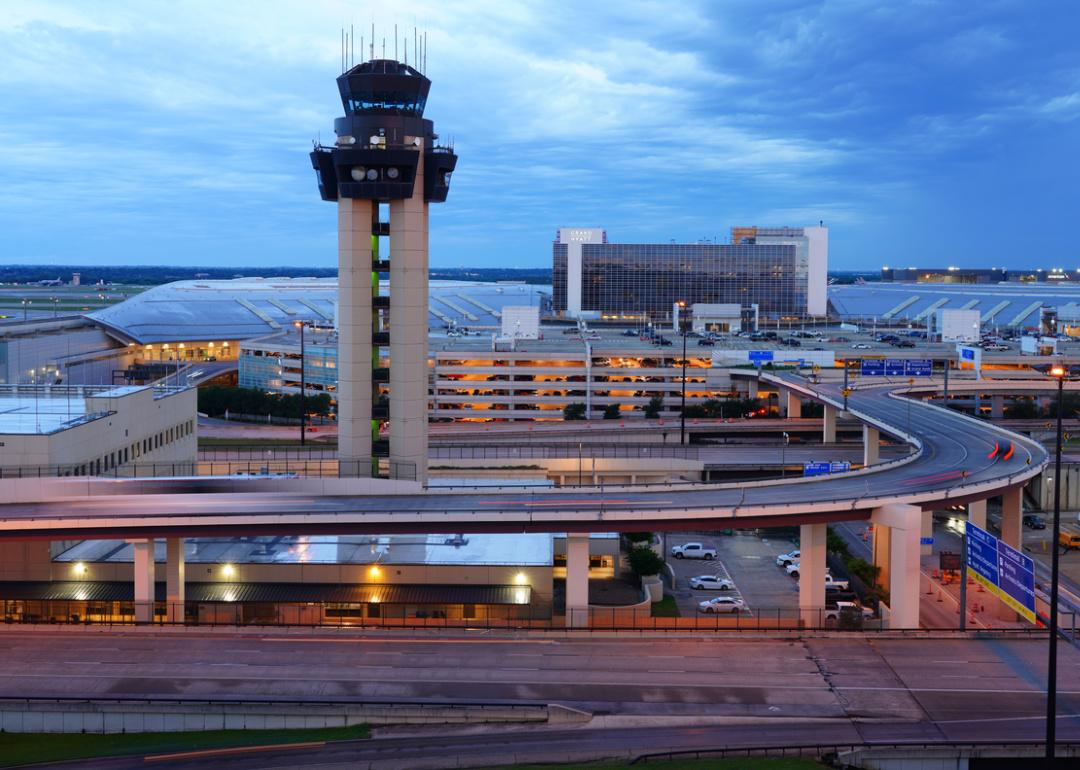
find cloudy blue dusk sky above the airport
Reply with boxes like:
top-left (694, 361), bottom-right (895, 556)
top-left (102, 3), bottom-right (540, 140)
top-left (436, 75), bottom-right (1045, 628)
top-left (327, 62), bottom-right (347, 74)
top-left (0, 0), bottom-right (1080, 269)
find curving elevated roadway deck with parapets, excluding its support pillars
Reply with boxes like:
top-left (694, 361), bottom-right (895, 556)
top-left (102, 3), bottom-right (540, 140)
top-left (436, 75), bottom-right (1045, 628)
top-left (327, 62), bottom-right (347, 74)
top-left (0, 375), bottom-right (1047, 539)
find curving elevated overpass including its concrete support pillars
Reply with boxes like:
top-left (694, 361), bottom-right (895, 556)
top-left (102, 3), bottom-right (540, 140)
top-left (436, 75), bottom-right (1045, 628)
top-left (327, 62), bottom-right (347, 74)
top-left (0, 375), bottom-right (1047, 627)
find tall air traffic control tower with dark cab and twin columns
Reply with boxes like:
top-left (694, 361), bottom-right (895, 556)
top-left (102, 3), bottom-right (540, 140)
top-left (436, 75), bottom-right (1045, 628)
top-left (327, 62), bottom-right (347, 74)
top-left (311, 58), bottom-right (458, 482)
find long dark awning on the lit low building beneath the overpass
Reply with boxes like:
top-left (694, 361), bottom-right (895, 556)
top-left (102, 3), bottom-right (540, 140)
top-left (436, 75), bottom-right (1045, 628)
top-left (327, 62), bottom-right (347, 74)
top-left (0, 580), bottom-right (531, 605)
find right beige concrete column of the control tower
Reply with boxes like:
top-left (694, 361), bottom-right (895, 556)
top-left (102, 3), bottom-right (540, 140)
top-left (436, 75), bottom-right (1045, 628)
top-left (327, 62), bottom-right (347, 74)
top-left (390, 133), bottom-right (428, 483)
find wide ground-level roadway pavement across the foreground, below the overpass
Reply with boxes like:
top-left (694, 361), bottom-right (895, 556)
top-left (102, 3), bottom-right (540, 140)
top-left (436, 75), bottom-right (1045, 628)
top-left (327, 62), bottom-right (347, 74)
top-left (6, 629), bottom-right (1080, 768)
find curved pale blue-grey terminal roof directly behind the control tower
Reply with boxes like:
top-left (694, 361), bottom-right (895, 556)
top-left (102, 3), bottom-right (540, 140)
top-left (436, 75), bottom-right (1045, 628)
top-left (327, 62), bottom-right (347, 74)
top-left (86, 278), bottom-right (551, 345)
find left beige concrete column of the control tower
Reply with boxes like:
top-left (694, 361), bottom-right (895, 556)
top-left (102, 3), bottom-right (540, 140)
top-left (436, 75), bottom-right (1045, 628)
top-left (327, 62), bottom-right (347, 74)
top-left (337, 198), bottom-right (378, 476)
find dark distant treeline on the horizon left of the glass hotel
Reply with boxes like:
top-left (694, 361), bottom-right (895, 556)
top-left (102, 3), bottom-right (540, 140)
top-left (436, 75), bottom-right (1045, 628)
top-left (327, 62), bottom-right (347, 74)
top-left (0, 265), bottom-right (551, 286)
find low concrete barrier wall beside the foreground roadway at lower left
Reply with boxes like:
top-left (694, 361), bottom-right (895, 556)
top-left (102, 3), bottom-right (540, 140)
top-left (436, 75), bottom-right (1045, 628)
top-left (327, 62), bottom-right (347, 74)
top-left (0, 699), bottom-right (557, 733)
